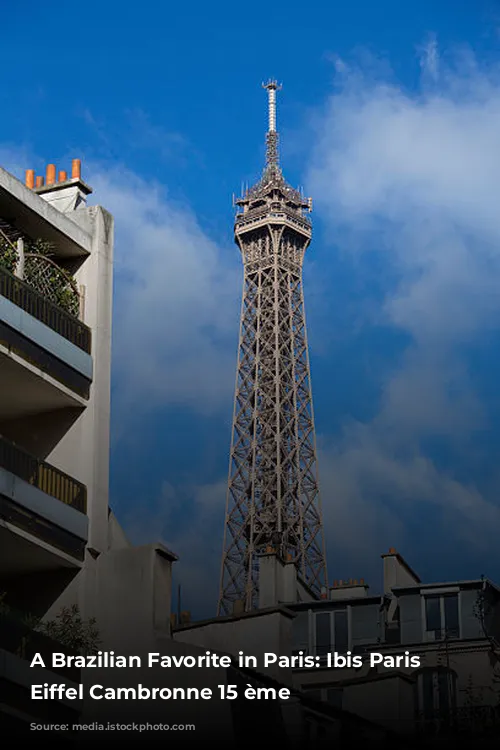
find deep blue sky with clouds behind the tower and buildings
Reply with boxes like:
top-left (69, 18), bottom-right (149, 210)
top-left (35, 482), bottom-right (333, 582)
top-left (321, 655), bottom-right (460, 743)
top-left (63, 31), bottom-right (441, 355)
top-left (0, 0), bottom-right (500, 614)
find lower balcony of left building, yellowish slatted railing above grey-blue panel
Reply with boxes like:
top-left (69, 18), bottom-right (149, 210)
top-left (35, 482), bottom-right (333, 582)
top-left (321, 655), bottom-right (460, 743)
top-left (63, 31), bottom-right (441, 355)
top-left (0, 437), bottom-right (88, 577)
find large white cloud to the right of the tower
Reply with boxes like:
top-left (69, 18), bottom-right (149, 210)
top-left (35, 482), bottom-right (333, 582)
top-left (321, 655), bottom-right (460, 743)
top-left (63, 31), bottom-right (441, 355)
top-left (309, 40), bottom-right (500, 580)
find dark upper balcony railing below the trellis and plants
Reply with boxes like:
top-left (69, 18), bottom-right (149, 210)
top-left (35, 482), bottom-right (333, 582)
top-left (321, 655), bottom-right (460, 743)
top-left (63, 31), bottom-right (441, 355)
top-left (0, 266), bottom-right (91, 354)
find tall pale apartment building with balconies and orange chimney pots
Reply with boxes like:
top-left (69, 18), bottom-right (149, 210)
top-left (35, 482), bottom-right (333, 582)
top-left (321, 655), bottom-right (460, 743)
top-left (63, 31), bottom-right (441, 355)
top-left (0, 159), bottom-right (113, 740)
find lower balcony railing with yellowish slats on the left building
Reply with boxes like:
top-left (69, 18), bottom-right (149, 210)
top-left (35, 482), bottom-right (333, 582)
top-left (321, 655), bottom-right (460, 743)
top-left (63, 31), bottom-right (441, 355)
top-left (0, 435), bottom-right (87, 513)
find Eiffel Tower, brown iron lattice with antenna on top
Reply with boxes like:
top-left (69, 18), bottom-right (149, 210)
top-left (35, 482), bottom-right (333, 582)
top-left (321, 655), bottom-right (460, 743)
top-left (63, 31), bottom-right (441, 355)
top-left (218, 81), bottom-right (327, 616)
